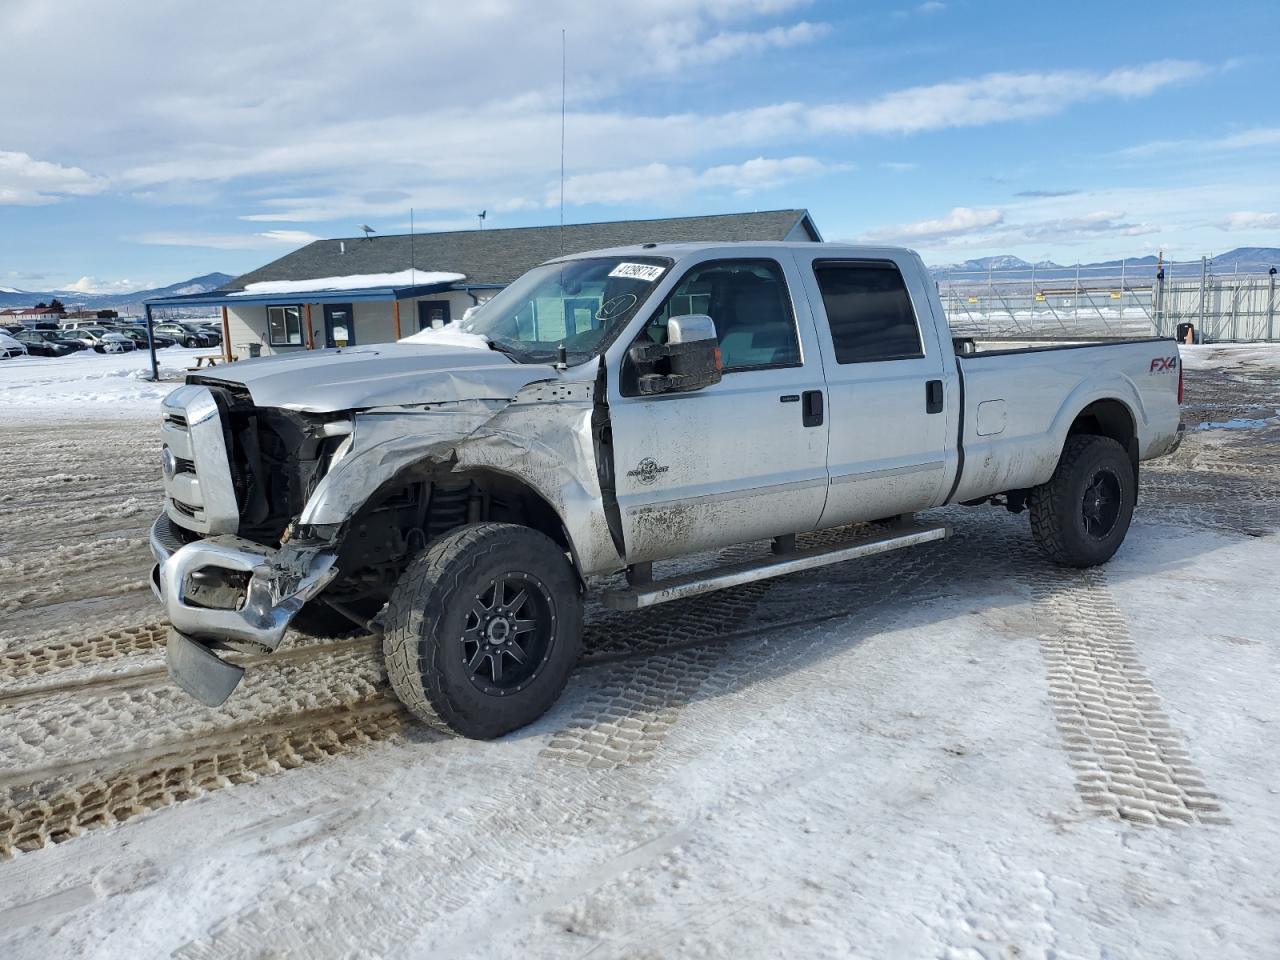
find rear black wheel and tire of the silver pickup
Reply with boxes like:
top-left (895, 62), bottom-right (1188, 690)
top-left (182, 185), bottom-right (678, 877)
top-left (1028, 434), bottom-right (1138, 567)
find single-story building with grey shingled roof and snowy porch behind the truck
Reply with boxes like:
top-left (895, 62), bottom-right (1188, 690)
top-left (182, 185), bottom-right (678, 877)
top-left (140, 210), bottom-right (822, 356)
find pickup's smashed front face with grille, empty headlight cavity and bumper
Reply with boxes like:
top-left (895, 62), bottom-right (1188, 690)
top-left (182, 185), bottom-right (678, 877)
top-left (150, 384), bottom-right (349, 705)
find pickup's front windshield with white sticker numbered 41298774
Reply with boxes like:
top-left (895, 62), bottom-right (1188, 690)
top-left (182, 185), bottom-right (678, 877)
top-left (435, 256), bottom-right (671, 364)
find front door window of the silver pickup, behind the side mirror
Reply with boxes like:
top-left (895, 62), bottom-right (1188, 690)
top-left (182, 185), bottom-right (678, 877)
top-left (640, 260), bottom-right (800, 374)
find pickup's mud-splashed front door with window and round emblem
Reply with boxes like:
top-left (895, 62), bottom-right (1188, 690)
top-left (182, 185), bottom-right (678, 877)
top-left (609, 259), bottom-right (827, 563)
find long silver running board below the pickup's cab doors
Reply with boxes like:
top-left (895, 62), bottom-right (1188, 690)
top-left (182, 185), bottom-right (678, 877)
top-left (600, 524), bottom-right (951, 611)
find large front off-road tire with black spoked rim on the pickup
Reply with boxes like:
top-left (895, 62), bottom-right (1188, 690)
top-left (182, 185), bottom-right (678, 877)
top-left (383, 524), bottom-right (582, 740)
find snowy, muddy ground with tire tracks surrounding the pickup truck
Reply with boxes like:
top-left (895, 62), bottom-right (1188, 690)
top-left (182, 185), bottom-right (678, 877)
top-left (0, 347), bottom-right (1280, 959)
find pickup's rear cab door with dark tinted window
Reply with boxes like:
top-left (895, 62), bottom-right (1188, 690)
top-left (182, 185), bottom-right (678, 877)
top-left (796, 251), bottom-right (952, 526)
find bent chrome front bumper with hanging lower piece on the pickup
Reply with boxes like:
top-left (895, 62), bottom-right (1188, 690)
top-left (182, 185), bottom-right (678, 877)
top-left (150, 513), bottom-right (338, 707)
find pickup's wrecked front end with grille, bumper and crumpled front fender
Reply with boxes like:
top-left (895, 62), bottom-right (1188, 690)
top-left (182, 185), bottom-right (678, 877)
top-left (151, 365), bottom-right (621, 705)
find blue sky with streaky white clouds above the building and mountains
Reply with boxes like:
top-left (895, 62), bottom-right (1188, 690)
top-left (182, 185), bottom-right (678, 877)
top-left (0, 0), bottom-right (1280, 292)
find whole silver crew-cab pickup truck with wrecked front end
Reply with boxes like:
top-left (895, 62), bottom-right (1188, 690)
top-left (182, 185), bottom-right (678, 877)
top-left (151, 243), bottom-right (1181, 737)
